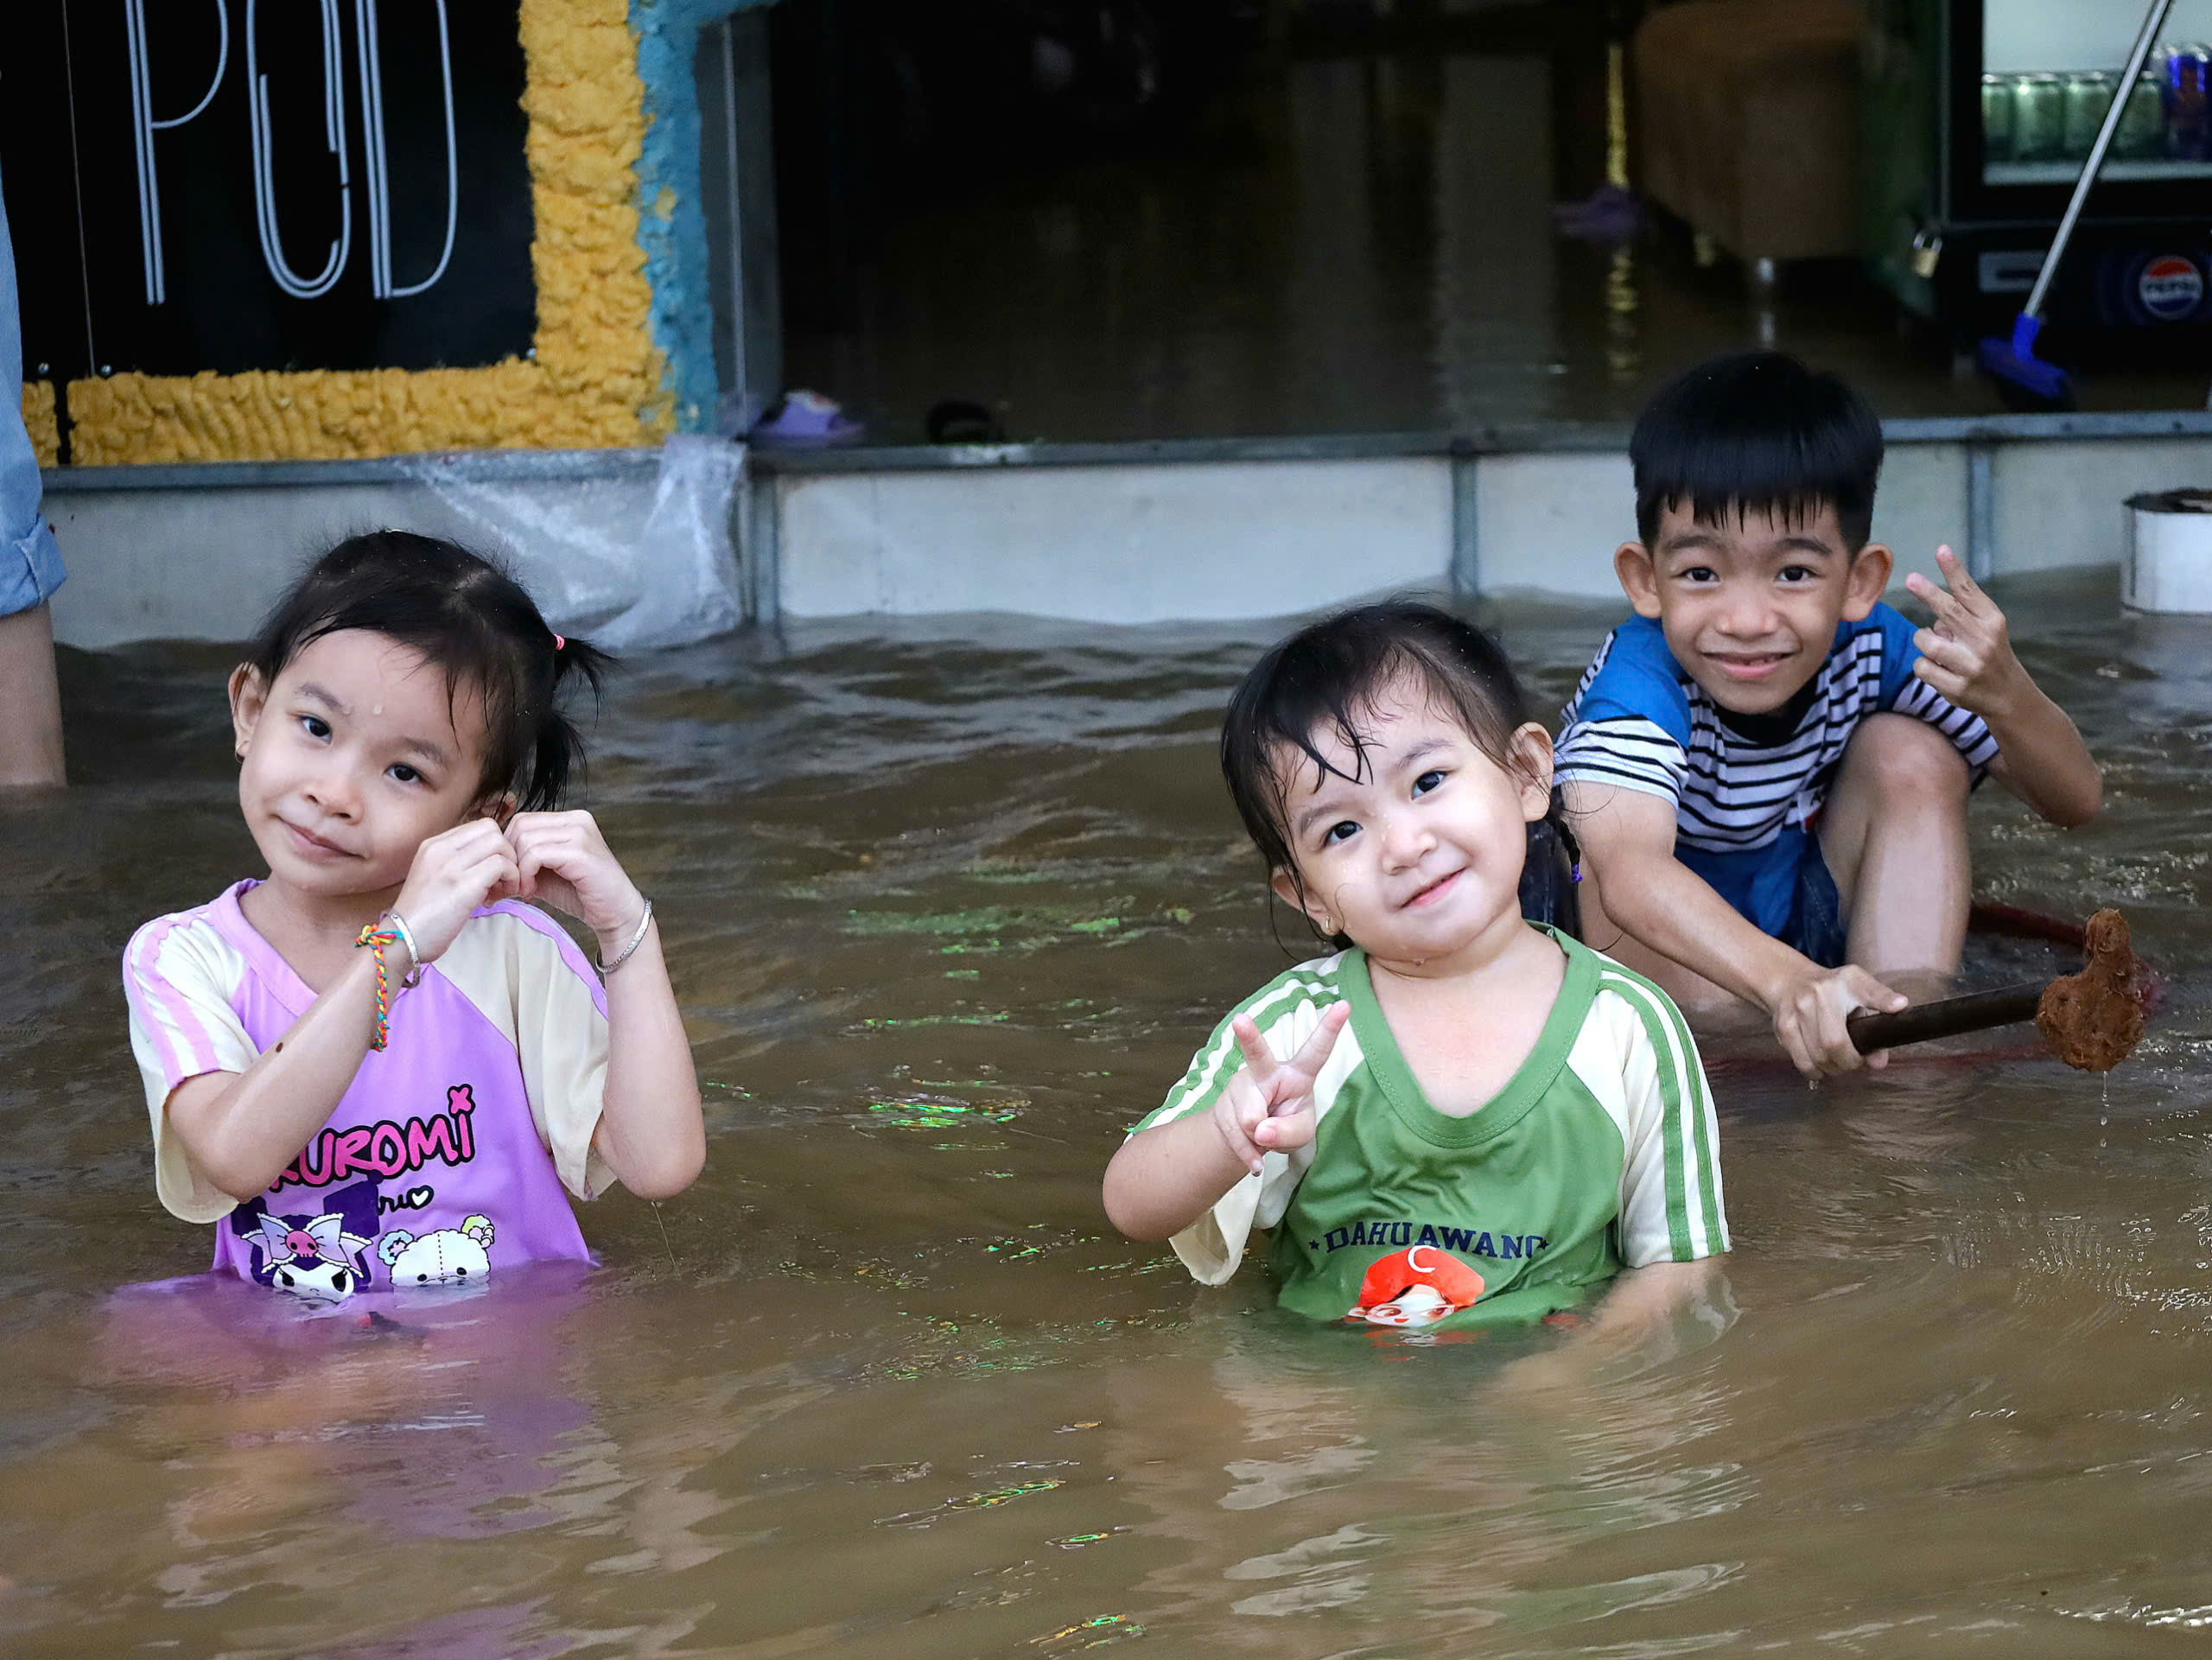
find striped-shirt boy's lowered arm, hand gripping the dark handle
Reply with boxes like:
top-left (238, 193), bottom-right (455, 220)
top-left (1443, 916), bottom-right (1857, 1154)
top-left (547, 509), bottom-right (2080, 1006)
top-left (1564, 779), bottom-right (1907, 1078)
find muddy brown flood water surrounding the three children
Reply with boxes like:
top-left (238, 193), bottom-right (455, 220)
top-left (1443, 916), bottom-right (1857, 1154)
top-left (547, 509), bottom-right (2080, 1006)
top-left (0, 573), bottom-right (2212, 1660)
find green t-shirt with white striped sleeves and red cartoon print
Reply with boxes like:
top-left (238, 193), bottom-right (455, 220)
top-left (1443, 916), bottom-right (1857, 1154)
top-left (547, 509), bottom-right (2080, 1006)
top-left (1139, 930), bottom-right (1727, 1328)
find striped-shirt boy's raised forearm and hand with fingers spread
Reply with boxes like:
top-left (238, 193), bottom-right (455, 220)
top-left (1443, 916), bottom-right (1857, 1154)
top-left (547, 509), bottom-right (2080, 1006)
top-left (1904, 547), bottom-right (2104, 830)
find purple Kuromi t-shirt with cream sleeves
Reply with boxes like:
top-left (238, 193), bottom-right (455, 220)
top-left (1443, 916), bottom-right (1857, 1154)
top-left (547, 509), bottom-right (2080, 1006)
top-left (124, 881), bottom-right (613, 1304)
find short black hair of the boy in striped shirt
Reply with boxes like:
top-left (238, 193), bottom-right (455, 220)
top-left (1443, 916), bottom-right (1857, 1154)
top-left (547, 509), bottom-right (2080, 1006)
top-left (1628, 352), bottom-right (1883, 553)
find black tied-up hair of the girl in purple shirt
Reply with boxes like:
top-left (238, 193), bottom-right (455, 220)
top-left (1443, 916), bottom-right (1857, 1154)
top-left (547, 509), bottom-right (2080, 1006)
top-left (245, 531), bottom-right (615, 812)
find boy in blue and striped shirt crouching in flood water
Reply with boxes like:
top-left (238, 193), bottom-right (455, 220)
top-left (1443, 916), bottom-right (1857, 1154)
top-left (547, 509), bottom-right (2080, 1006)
top-left (1557, 352), bottom-right (2104, 1076)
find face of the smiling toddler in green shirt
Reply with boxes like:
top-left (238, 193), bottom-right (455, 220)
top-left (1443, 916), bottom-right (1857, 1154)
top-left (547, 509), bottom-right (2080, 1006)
top-left (1274, 677), bottom-right (1551, 967)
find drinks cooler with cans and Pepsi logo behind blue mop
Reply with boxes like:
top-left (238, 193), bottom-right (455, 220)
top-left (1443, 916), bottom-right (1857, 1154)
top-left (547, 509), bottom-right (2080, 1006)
top-left (1863, 0), bottom-right (2212, 363)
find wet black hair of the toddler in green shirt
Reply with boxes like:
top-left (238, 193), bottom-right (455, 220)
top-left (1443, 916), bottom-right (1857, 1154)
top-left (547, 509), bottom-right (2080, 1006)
top-left (1221, 600), bottom-right (1577, 945)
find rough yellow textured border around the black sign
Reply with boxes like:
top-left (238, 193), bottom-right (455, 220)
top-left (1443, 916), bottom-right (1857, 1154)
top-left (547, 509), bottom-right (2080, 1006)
top-left (64, 0), bottom-right (675, 465)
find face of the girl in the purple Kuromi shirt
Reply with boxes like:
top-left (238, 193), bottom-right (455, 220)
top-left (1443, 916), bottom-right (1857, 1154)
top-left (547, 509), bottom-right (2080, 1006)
top-left (230, 628), bottom-right (489, 899)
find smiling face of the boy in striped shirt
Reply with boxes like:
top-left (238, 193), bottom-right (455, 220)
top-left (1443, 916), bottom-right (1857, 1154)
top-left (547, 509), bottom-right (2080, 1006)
top-left (1612, 505), bottom-right (1891, 715)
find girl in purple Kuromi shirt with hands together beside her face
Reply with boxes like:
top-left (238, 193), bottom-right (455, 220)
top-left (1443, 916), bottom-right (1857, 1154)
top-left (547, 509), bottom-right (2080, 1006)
top-left (124, 531), bottom-right (706, 1304)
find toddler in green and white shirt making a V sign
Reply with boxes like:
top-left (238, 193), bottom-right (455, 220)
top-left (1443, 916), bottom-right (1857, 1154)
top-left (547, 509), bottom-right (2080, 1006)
top-left (1106, 602), bottom-right (1727, 1328)
